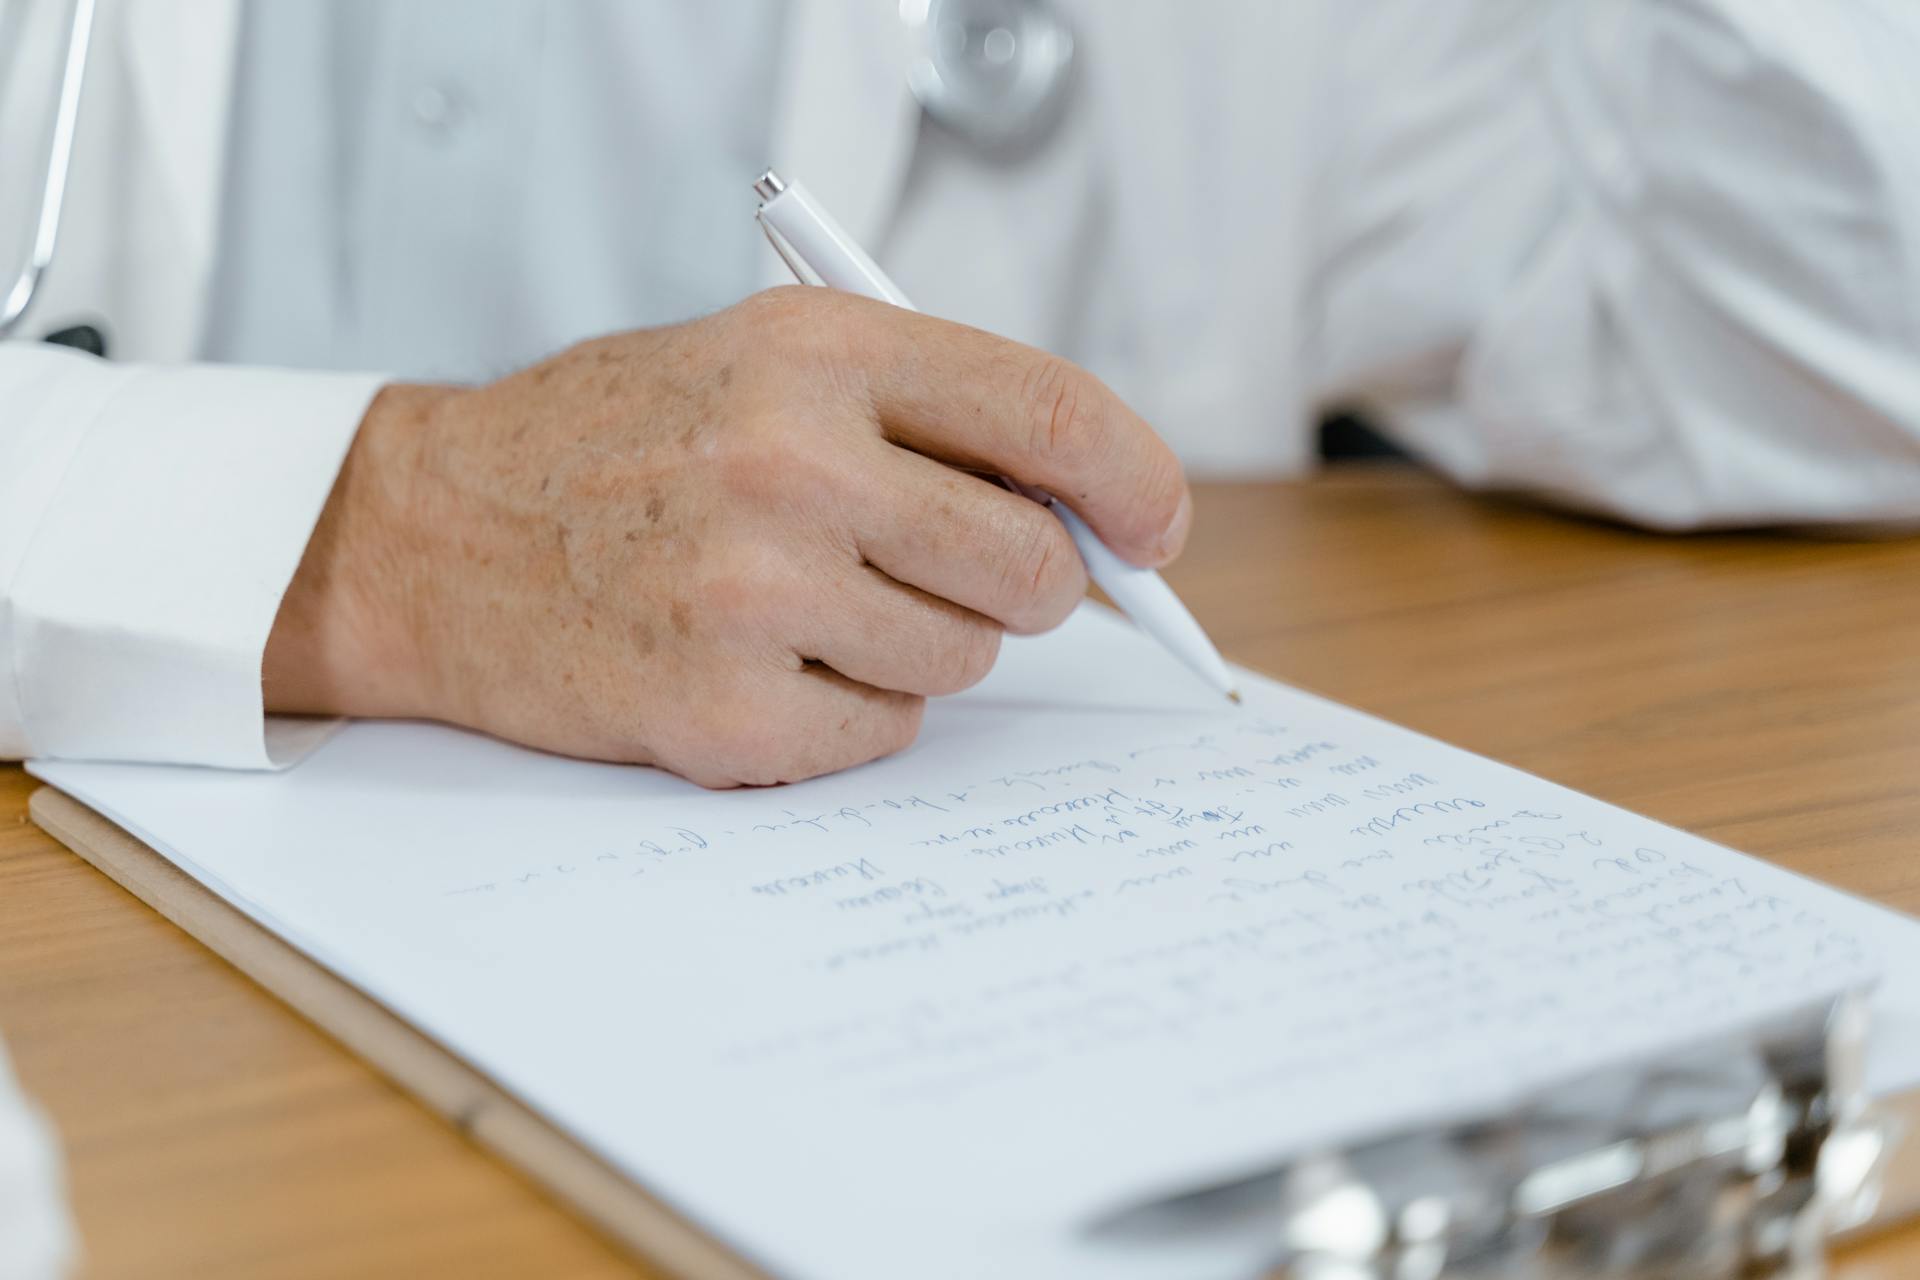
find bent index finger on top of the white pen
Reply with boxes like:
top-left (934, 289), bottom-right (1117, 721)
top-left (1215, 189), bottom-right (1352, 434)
top-left (825, 299), bottom-right (1192, 564)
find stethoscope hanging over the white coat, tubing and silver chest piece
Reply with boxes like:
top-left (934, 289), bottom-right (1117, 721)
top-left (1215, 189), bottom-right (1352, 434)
top-left (0, 0), bottom-right (1073, 338)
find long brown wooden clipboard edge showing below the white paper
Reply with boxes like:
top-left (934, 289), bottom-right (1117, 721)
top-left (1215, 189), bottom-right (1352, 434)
top-left (27, 787), bottom-right (766, 1280)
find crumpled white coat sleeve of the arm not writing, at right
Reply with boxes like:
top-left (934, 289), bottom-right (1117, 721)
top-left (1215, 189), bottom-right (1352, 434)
top-left (1411, 0), bottom-right (1920, 530)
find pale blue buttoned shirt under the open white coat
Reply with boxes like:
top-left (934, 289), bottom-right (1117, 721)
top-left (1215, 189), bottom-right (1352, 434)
top-left (202, 0), bottom-right (783, 382)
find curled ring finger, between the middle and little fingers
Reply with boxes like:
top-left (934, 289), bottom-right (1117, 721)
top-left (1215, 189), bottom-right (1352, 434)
top-left (793, 564), bottom-right (1000, 697)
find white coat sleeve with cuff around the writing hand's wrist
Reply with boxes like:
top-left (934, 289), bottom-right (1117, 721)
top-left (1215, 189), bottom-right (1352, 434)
top-left (0, 342), bottom-right (382, 768)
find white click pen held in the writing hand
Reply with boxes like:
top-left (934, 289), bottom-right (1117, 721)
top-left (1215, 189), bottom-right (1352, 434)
top-left (753, 169), bottom-right (1240, 702)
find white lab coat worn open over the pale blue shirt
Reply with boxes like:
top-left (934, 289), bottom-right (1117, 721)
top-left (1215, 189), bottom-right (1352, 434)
top-left (0, 0), bottom-right (1920, 766)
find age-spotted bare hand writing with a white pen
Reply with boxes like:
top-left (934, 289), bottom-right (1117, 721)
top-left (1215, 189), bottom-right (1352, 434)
top-left (263, 288), bottom-right (1192, 787)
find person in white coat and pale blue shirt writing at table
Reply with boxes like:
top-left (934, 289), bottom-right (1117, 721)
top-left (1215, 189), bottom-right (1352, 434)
top-left (0, 0), bottom-right (1920, 785)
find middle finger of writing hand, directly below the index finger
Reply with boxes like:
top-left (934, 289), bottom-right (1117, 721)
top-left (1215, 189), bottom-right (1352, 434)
top-left (854, 449), bottom-right (1087, 635)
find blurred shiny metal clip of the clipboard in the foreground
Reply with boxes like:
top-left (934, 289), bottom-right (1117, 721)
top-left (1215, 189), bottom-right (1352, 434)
top-left (1269, 994), bottom-right (1899, 1280)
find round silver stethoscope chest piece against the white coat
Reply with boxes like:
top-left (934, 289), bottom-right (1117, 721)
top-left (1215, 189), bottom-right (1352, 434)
top-left (900, 0), bottom-right (1073, 152)
